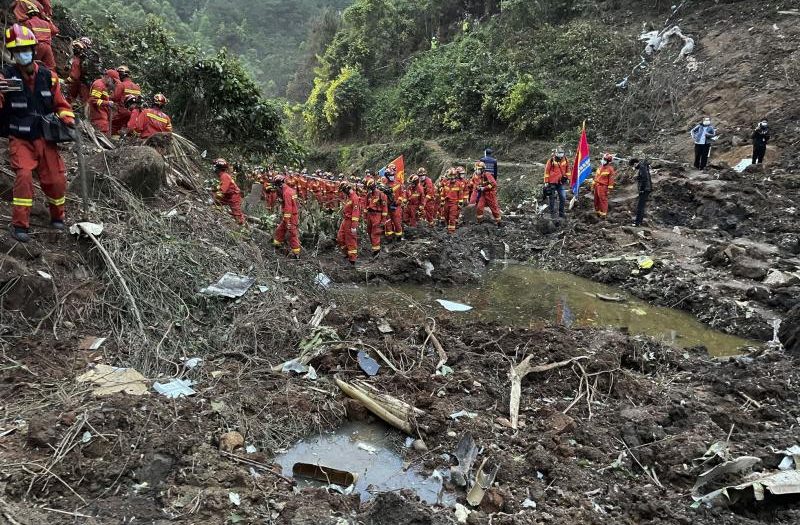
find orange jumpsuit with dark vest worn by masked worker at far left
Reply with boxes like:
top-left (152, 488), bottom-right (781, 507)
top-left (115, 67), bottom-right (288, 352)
top-left (0, 63), bottom-right (75, 229)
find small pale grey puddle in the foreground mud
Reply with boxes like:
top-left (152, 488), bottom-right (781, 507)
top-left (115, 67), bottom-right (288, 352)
top-left (275, 422), bottom-right (455, 506)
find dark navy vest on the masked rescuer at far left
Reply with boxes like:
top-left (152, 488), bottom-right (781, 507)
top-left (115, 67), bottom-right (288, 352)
top-left (0, 65), bottom-right (55, 140)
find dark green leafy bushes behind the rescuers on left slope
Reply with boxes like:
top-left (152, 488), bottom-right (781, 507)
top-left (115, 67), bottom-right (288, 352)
top-left (72, 15), bottom-right (294, 154)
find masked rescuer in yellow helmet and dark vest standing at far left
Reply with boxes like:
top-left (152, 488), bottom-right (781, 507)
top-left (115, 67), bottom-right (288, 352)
top-left (0, 24), bottom-right (75, 242)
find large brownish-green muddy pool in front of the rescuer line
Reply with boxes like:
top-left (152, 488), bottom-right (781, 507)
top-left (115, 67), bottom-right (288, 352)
top-left (362, 264), bottom-right (759, 356)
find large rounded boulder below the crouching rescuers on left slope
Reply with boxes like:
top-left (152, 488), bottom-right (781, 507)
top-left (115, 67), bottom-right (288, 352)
top-left (78, 146), bottom-right (166, 198)
